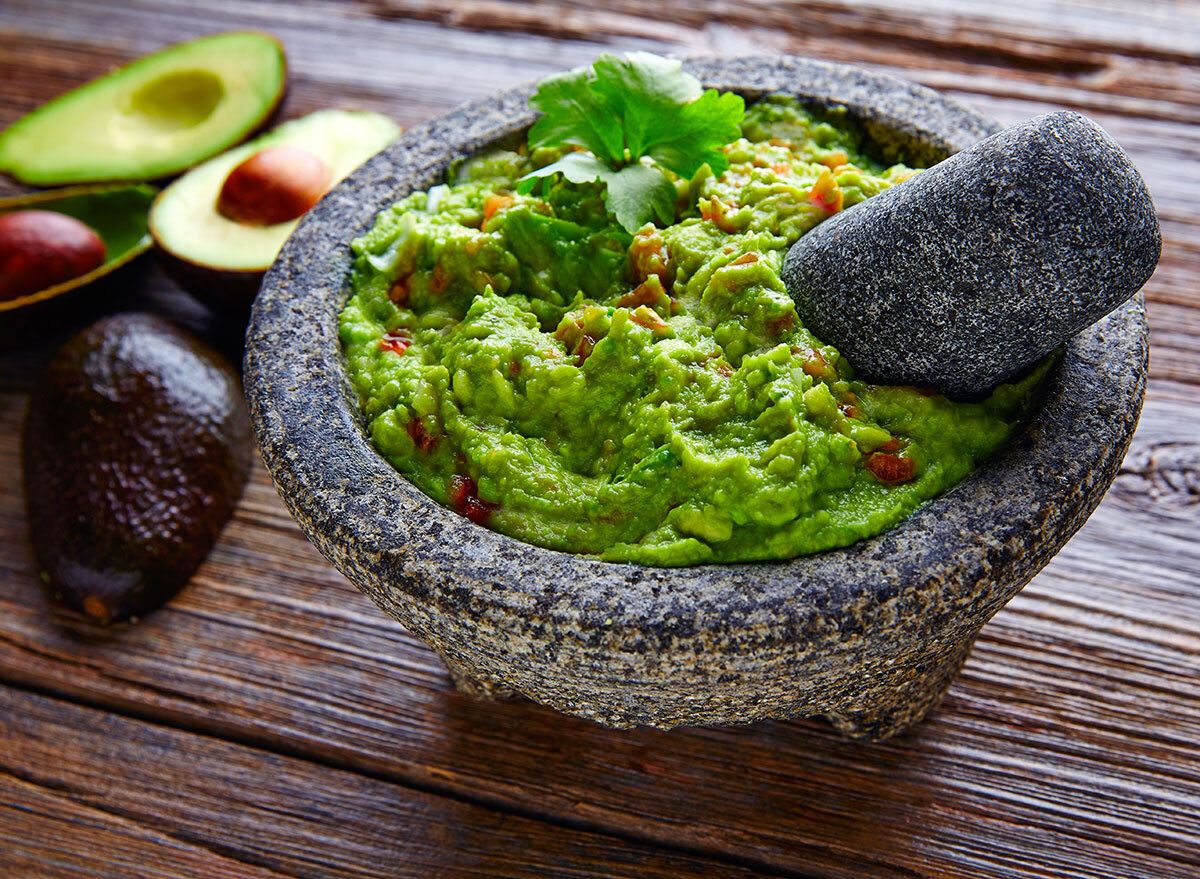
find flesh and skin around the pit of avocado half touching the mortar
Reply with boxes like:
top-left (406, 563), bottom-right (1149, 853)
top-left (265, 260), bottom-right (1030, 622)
top-left (150, 109), bottom-right (400, 307)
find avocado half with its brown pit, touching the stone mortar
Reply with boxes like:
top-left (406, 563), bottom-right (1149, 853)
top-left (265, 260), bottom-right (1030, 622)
top-left (150, 109), bottom-right (400, 309)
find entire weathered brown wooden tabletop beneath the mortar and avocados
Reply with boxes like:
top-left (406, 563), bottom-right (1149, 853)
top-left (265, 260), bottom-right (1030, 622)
top-left (0, 0), bottom-right (1200, 879)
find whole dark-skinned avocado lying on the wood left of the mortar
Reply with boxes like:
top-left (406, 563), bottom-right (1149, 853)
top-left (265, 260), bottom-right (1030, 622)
top-left (23, 313), bottom-right (253, 623)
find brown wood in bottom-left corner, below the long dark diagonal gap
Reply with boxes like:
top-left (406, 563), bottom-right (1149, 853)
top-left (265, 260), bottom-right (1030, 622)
top-left (0, 686), bottom-right (761, 879)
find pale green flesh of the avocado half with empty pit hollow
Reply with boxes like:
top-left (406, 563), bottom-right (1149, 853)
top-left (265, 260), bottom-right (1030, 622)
top-left (0, 31), bottom-right (287, 186)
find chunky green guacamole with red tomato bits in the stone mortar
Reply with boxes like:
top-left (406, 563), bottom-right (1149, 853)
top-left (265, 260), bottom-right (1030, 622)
top-left (340, 97), bottom-right (1045, 566)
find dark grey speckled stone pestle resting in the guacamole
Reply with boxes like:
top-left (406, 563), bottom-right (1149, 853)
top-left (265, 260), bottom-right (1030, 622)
top-left (782, 112), bottom-right (1162, 399)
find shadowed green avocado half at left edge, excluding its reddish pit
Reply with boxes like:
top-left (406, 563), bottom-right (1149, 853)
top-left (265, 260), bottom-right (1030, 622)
top-left (0, 184), bottom-right (158, 312)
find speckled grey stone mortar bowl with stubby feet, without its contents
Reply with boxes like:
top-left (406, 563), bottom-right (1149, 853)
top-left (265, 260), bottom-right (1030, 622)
top-left (245, 58), bottom-right (1147, 740)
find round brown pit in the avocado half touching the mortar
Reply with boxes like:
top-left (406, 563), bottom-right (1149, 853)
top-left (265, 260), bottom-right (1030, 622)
top-left (217, 145), bottom-right (332, 226)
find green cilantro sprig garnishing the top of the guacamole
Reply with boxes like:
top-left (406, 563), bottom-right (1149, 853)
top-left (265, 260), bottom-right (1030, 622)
top-left (517, 52), bottom-right (745, 232)
